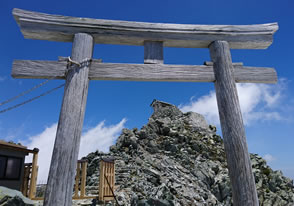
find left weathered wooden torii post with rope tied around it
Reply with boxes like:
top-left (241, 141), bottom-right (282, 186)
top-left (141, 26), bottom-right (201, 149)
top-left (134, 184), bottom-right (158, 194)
top-left (44, 33), bottom-right (94, 206)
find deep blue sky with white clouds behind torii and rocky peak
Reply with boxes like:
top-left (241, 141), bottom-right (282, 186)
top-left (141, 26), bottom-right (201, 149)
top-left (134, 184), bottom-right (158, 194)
top-left (0, 0), bottom-right (294, 182)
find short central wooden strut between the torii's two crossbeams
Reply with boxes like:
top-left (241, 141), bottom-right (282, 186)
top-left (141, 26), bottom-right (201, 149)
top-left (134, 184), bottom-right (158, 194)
top-left (144, 41), bottom-right (163, 64)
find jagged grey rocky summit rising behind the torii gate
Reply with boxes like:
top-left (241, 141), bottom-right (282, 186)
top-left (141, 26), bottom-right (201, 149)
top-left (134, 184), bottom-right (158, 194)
top-left (85, 100), bottom-right (294, 206)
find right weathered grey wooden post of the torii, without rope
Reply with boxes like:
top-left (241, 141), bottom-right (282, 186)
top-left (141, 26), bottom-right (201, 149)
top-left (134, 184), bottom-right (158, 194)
top-left (209, 41), bottom-right (259, 206)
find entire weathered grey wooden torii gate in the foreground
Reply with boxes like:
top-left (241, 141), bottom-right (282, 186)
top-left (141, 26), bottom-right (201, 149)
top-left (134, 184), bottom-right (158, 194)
top-left (12, 9), bottom-right (278, 206)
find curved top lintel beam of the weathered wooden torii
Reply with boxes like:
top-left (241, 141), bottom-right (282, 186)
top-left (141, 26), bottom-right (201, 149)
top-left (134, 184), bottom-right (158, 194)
top-left (13, 9), bottom-right (278, 49)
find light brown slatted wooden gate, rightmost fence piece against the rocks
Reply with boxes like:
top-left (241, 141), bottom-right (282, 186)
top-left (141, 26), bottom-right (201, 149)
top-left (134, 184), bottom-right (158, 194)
top-left (99, 158), bottom-right (115, 201)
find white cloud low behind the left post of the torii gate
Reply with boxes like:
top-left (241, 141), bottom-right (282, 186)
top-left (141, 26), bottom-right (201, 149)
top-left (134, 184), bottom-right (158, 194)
top-left (23, 119), bottom-right (126, 183)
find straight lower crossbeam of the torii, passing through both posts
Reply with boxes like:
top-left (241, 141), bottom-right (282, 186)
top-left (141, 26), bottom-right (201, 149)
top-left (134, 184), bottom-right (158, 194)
top-left (12, 60), bottom-right (277, 83)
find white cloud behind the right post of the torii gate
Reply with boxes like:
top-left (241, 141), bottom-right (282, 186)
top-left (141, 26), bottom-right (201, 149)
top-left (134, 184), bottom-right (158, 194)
top-left (179, 80), bottom-right (284, 125)
